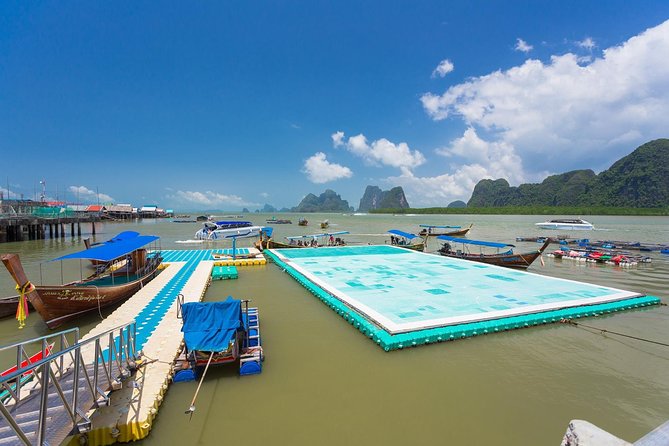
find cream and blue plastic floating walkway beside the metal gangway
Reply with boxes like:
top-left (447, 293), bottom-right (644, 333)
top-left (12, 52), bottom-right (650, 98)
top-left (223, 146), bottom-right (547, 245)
top-left (71, 249), bottom-right (264, 445)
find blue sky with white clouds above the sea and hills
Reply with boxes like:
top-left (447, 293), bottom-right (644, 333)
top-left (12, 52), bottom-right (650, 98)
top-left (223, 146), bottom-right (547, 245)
top-left (0, 0), bottom-right (669, 210)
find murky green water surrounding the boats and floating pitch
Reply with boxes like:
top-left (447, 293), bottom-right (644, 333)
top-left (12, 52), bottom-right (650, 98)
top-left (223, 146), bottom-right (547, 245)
top-left (0, 214), bottom-right (669, 445)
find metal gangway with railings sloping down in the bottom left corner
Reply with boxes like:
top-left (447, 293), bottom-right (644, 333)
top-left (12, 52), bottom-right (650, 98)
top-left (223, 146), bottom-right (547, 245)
top-left (0, 321), bottom-right (138, 446)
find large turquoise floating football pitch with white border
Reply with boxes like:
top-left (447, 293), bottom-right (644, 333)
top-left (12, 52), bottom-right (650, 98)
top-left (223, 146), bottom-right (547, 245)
top-left (265, 245), bottom-right (660, 351)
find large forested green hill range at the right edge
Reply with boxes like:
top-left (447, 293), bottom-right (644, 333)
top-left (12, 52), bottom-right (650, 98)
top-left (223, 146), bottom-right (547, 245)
top-left (467, 139), bottom-right (669, 208)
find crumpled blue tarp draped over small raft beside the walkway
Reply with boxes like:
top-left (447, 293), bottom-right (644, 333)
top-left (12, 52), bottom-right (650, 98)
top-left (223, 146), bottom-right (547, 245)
top-left (181, 296), bottom-right (242, 352)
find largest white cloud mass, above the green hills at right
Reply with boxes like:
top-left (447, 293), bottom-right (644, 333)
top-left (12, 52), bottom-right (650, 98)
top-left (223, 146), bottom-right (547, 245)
top-left (421, 21), bottom-right (669, 173)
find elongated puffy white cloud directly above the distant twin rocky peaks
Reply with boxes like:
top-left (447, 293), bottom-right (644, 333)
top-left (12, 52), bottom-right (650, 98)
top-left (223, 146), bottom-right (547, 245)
top-left (333, 132), bottom-right (425, 169)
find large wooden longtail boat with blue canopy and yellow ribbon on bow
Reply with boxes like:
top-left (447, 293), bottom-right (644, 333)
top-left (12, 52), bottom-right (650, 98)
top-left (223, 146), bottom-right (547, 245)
top-left (0, 235), bottom-right (162, 329)
